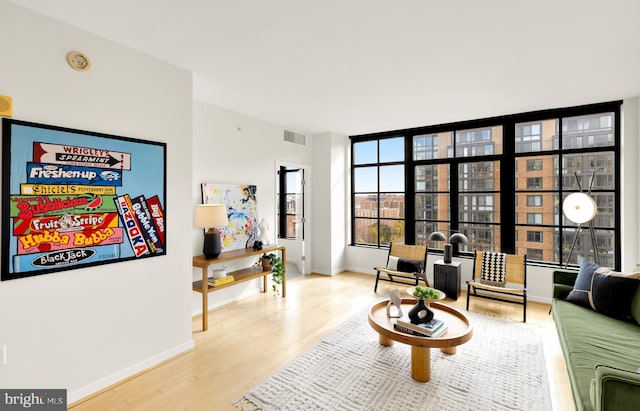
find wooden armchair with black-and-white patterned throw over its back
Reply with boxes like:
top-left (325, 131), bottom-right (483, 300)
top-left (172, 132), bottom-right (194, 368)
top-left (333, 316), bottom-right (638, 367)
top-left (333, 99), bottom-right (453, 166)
top-left (467, 250), bottom-right (527, 322)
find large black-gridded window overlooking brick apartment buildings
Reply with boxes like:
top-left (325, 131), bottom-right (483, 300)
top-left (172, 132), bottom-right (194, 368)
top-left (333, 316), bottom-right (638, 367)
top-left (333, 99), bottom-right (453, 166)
top-left (351, 102), bottom-right (621, 268)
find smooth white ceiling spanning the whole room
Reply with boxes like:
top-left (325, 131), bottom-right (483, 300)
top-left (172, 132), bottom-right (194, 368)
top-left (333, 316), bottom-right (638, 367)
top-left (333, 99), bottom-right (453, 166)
top-left (12, 0), bottom-right (640, 135)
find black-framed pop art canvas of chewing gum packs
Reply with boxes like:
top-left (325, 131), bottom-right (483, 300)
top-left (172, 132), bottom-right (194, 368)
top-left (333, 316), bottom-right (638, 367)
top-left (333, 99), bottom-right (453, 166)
top-left (1, 118), bottom-right (166, 281)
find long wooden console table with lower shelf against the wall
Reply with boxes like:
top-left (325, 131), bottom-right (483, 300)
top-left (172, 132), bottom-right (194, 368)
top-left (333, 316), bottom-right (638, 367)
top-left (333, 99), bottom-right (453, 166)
top-left (192, 245), bottom-right (287, 331)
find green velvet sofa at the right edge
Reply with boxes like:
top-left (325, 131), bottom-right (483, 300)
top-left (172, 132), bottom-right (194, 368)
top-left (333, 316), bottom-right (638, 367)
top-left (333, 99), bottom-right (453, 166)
top-left (551, 270), bottom-right (640, 411)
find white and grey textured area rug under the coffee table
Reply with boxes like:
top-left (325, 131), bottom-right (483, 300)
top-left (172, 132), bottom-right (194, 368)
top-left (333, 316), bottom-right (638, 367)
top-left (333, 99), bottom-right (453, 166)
top-left (235, 310), bottom-right (551, 411)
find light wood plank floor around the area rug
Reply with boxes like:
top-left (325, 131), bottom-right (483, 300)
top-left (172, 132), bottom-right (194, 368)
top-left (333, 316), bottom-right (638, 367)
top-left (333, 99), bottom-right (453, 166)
top-left (70, 272), bottom-right (574, 411)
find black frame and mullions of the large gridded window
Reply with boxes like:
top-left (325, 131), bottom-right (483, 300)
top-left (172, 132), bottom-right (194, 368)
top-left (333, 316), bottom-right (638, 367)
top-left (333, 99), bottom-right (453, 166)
top-left (349, 100), bottom-right (622, 269)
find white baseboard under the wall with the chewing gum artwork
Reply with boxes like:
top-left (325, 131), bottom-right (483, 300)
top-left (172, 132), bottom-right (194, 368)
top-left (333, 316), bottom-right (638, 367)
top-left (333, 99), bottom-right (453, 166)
top-left (67, 340), bottom-right (195, 404)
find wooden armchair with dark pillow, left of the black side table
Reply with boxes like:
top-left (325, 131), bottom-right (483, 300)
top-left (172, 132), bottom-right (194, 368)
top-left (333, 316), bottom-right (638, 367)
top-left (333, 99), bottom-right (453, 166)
top-left (373, 243), bottom-right (429, 292)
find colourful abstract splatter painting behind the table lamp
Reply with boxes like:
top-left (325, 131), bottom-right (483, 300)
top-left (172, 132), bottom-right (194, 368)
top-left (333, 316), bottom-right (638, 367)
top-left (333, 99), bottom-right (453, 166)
top-left (202, 183), bottom-right (258, 251)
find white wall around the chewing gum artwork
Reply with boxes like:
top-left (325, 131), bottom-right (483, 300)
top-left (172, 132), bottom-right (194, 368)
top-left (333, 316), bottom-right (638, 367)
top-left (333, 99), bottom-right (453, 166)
top-left (0, 0), bottom-right (193, 403)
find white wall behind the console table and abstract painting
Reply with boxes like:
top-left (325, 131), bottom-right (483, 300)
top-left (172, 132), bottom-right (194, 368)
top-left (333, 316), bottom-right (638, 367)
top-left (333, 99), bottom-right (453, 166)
top-left (191, 101), bottom-right (314, 313)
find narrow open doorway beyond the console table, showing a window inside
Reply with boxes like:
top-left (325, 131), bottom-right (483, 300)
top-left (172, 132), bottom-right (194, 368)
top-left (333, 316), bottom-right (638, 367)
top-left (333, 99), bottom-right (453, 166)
top-left (276, 164), bottom-right (310, 278)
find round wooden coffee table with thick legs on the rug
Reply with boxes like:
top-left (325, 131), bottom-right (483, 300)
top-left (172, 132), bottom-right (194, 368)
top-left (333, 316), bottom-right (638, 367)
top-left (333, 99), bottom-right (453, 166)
top-left (369, 298), bottom-right (473, 382)
